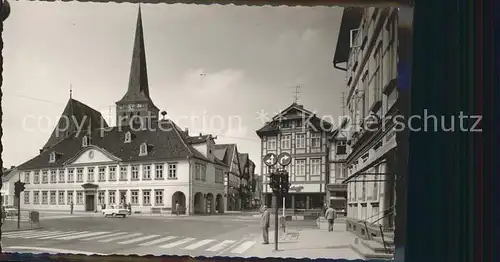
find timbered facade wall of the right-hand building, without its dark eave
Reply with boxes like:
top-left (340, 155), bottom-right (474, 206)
top-left (347, 8), bottom-right (397, 224)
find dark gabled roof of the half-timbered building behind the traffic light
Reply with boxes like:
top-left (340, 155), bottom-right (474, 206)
top-left (256, 103), bottom-right (333, 137)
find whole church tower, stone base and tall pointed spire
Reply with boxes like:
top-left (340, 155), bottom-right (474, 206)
top-left (116, 6), bottom-right (159, 126)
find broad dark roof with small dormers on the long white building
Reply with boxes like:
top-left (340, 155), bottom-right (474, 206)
top-left (18, 121), bottom-right (223, 170)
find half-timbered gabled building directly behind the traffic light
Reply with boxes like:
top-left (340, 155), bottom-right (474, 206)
top-left (256, 103), bottom-right (333, 209)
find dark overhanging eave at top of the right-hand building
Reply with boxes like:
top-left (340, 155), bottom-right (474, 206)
top-left (333, 7), bottom-right (364, 68)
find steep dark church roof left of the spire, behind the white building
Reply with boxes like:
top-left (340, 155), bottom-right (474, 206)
top-left (43, 98), bottom-right (108, 148)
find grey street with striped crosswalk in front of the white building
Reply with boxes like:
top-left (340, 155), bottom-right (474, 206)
top-left (2, 215), bottom-right (270, 256)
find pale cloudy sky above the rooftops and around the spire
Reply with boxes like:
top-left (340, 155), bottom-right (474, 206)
top-left (2, 2), bottom-right (346, 170)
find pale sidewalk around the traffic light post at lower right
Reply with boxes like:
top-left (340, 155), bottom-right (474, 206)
top-left (241, 223), bottom-right (363, 260)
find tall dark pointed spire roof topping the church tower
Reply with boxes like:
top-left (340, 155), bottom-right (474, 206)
top-left (117, 6), bottom-right (153, 103)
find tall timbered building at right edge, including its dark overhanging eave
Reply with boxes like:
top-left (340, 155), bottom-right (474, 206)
top-left (334, 7), bottom-right (398, 237)
